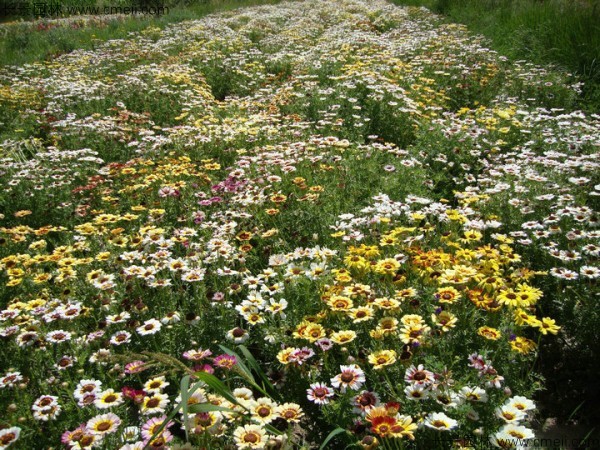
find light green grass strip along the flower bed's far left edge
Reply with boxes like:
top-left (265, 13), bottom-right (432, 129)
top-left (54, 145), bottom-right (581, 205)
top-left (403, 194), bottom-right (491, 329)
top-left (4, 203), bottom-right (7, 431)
top-left (0, 0), bottom-right (288, 66)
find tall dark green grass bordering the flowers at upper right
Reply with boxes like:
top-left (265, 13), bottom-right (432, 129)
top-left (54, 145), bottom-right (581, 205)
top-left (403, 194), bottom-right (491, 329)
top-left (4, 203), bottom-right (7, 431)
top-left (392, 0), bottom-right (600, 111)
